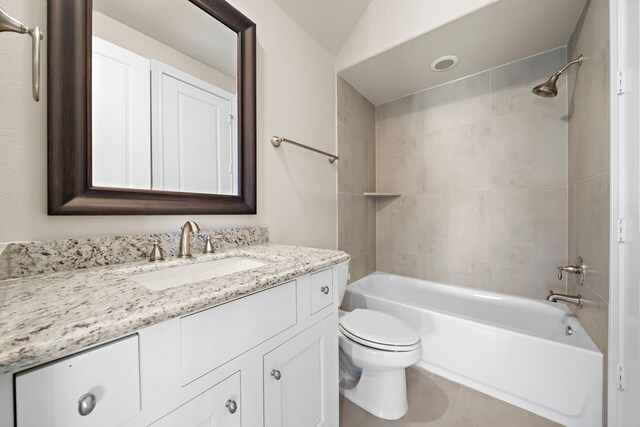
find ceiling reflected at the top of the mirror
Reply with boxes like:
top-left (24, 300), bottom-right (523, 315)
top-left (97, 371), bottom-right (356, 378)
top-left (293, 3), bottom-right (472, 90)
top-left (93, 0), bottom-right (237, 78)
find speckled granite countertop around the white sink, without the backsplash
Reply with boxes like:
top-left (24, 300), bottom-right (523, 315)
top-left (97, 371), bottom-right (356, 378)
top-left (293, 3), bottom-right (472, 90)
top-left (0, 244), bottom-right (349, 374)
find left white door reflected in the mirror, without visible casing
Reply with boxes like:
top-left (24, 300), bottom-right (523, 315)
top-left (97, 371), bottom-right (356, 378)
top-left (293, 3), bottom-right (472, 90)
top-left (91, 37), bottom-right (151, 190)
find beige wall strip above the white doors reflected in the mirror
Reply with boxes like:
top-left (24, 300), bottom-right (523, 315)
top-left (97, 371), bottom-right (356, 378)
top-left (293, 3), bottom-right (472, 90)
top-left (93, 11), bottom-right (236, 93)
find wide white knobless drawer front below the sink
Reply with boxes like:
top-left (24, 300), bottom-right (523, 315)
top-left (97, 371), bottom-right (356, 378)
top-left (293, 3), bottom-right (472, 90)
top-left (180, 281), bottom-right (297, 385)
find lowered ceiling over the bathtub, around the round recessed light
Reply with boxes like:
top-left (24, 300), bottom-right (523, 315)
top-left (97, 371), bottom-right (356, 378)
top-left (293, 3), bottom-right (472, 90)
top-left (340, 0), bottom-right (586, 105)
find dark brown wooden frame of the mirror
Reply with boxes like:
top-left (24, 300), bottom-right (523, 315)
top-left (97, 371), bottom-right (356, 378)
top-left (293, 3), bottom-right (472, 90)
top-left (48, 0), bottom-right (256, 215)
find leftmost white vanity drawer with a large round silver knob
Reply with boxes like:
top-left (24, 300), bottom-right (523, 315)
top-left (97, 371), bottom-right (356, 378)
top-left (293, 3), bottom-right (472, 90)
top-left (15, 335), bottom-right (140, 427)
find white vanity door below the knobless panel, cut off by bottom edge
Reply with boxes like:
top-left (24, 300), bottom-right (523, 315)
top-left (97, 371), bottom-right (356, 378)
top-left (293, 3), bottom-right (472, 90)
top-left (151, 372), bottom-right (242, 427)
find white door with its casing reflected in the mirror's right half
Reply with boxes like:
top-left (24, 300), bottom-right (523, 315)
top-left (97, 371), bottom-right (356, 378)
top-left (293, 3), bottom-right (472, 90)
top-left (151, 60), bottom-right (237, 194)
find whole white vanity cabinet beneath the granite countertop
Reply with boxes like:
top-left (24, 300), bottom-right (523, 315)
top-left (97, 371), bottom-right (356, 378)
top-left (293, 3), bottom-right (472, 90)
top-left (0, 266), bottom-right (341, 427)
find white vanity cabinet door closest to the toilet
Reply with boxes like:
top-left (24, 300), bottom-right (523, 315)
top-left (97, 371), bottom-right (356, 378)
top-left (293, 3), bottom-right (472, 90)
top-left (264, 316), bottom-right (338, 427)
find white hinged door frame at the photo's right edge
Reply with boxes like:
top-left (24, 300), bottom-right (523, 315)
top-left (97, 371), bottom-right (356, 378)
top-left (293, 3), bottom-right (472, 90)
top-left (608, 0), bottom-right (640, 427)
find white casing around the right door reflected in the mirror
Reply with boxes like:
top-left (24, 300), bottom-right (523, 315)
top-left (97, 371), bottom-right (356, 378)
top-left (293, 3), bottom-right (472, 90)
top-left (151, 59), bottom-right (239, 194)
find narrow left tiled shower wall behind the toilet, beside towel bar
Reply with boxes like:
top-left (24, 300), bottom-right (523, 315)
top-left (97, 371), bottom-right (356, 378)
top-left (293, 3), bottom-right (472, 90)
top-left (337, 76), bottom-right (376, 282)
